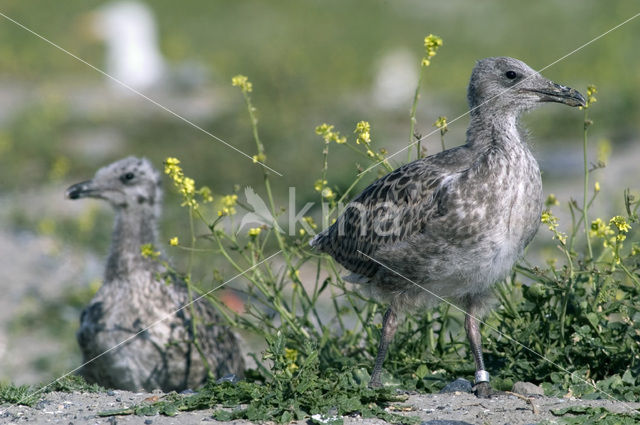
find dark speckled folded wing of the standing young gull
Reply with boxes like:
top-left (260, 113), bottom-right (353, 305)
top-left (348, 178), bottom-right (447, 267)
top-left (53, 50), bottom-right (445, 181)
top-left (311, 147), bottom-right (470, 277)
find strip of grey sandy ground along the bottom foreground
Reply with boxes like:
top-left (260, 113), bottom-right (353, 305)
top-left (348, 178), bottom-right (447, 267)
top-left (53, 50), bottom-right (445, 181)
top-left (0, 391), bottom-right (640, 425)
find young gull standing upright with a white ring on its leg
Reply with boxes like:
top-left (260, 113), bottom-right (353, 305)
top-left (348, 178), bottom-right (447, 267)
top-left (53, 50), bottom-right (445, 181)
top-left (311, 57), bottom-right (585, 397)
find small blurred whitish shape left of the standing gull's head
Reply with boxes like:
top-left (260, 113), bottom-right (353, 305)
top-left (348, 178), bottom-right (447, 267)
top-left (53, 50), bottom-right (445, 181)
top-left (371, 49), bottom-right (420, 110)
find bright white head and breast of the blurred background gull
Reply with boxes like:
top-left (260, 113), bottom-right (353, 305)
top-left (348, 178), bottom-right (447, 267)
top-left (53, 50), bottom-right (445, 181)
top-left (94, 1), bottom-right (167, 90)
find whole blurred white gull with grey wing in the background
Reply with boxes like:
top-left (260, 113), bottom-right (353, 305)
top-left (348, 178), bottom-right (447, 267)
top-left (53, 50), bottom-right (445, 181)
top-left (85, 0), bottom-right (223, 120)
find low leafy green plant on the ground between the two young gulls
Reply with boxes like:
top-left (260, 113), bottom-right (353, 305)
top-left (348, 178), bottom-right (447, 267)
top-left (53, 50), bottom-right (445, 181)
top-left (100, 332), bottom-right (420, 424)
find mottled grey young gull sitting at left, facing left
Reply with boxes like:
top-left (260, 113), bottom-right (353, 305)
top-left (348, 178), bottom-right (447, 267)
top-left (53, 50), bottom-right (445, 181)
top-left (66, 157), bottom-right (244, 391)
